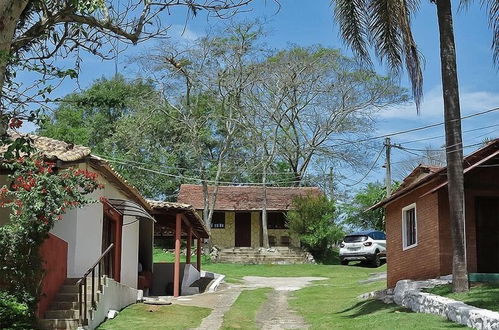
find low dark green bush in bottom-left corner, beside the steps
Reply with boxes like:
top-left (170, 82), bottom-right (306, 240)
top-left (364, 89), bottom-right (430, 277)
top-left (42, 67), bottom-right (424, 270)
top-left (0, 291), bottom-right (33, 329)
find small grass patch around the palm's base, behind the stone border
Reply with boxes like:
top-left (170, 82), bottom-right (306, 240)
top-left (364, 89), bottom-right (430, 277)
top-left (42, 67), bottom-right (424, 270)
top-left (425, 284), bottom-right (499, 312)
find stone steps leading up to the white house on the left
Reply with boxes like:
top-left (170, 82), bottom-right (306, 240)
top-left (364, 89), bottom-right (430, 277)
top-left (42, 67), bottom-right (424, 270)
top-left (39, 278), bottom-right (99, 330)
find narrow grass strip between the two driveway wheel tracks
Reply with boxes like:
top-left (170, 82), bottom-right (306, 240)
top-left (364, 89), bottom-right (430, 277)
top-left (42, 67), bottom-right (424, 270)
top-left (222, 288), bottom-right (272, 330)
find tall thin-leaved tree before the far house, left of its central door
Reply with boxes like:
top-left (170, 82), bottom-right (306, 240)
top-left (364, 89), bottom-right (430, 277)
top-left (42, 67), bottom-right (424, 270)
top-left (144, 24), bottom-right (259, 228)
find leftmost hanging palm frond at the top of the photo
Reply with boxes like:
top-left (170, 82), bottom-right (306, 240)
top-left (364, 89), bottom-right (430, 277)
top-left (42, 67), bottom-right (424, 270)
top-left (331, 0), bottom-right (372, 64)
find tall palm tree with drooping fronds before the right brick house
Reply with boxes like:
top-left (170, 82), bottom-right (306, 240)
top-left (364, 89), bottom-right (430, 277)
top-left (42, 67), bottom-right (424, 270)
top-left (331, 0), bottom-right (499, 292)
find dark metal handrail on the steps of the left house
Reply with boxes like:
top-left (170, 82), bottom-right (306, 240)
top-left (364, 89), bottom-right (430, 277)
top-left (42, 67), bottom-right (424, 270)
top-left (76, 243), bottom-right (114, 326)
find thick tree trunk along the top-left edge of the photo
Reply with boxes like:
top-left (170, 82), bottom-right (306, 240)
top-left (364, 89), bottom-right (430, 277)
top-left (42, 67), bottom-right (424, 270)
top-left (0, 0), bottom-right (29, 137)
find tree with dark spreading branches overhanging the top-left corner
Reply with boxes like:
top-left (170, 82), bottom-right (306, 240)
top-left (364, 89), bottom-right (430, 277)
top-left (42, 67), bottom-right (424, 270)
top-left (0, 0), bottom-right (252, 139)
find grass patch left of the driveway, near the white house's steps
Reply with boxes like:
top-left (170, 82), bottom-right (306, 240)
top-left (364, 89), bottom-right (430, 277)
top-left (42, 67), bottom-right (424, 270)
top-left (98, 304), bottom-right (211, 330)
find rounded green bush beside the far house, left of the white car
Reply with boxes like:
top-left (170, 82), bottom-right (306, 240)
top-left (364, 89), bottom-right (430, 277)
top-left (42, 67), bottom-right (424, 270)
top-left (288, 195), bottom-right (344, 262)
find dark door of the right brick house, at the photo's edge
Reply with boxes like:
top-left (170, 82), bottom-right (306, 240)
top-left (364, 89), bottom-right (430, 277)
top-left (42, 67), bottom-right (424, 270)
top-left (475, 197), bottom-right (499, 273)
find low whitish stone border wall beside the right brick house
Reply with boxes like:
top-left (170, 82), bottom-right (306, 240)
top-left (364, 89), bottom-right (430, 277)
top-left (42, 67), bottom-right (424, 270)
top-left (386, 279), bottom-right (499, 330)
